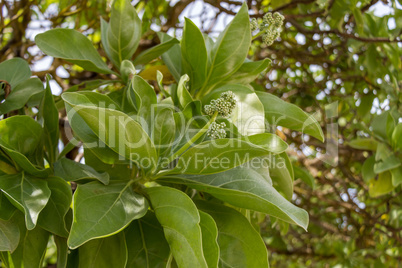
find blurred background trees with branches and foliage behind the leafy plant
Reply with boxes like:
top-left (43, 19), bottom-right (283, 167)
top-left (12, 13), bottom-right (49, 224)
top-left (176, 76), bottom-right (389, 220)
top-left (0, 0), bottom-right (402, 267)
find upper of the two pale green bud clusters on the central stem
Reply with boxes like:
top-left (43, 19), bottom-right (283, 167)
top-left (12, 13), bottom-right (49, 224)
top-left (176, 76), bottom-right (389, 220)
top-left (204, 91), bottom-right (236, 118)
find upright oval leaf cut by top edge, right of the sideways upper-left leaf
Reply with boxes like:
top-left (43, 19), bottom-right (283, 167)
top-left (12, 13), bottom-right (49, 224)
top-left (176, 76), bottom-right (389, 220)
top-left (103, 0), bottom-right (142, 68)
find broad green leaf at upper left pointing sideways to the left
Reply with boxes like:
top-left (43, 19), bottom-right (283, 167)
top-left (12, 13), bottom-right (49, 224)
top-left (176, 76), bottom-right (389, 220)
top-left (35, 28), bottom-right (112, 74)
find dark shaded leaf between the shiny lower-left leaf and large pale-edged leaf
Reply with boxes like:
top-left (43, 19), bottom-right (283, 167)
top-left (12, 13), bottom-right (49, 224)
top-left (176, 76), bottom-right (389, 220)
top-left (38, 177), bottom-right (72, 237)
